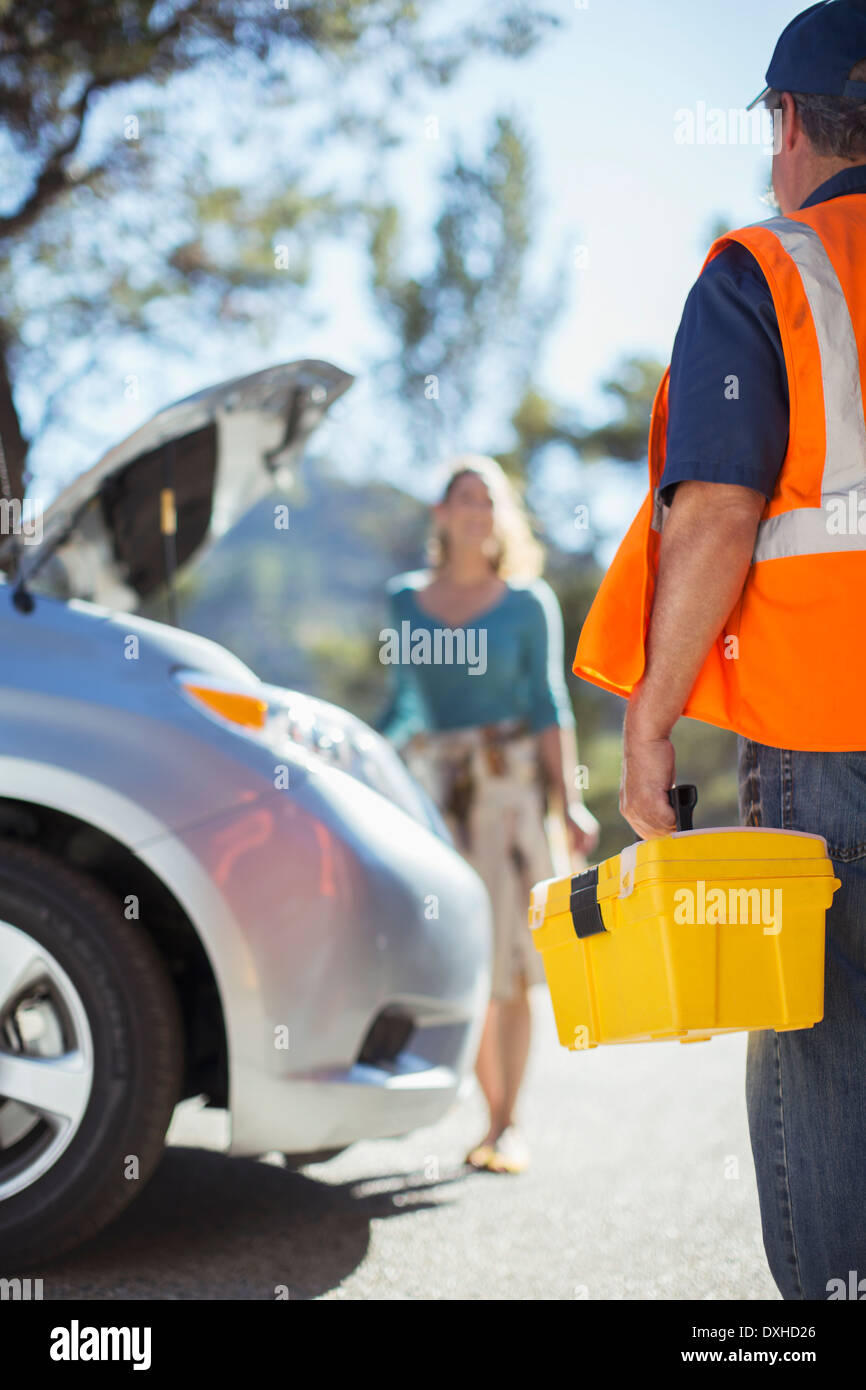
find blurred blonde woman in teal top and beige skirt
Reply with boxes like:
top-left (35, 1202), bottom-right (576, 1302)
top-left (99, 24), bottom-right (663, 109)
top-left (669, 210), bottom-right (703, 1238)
top-left (382, 455), bottom-right (598, 1172)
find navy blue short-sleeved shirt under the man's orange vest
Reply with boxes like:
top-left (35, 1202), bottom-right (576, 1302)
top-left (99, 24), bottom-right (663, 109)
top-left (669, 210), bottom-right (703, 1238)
top-left (662, 164), bottom-right (866, 503)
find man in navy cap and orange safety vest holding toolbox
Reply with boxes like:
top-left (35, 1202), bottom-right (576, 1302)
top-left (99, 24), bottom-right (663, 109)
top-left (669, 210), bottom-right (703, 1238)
top-left (574, 0), bottom-right (866, 1298)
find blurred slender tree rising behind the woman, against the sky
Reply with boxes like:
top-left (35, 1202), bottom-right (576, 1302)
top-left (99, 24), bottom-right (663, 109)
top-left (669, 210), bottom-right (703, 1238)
top-left (371, 115), bottom-right (559, 459)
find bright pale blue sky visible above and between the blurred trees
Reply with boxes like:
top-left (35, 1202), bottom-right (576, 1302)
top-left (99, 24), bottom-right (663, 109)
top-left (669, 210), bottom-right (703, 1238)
top-left (18, 0), bottom-right (802, 519)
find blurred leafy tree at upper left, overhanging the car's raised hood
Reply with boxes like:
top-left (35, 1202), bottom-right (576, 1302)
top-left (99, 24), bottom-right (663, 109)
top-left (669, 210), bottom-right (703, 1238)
top-left (0, 0), bottom-right (550, 496)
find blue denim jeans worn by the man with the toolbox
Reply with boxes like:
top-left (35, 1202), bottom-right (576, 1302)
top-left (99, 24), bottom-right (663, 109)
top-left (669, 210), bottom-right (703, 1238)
top-left (740, 738), bottom-right (866, 1300)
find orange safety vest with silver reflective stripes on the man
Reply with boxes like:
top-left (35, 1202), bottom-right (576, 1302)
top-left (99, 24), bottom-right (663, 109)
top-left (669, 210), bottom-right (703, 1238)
top-left (574, 193), bottom-right (866, 752)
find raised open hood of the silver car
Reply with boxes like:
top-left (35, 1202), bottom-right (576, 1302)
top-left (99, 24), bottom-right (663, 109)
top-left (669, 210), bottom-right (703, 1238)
top-left (6, 361), bottom-right (354, 607)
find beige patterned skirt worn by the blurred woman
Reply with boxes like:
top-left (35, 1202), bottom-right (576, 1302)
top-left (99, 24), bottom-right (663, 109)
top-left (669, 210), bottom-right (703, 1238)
top-left (405, 724), bottom-right (558, 999)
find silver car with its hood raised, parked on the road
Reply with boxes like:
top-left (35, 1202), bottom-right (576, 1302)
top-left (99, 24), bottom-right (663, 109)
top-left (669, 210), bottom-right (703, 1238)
top-left (0, 361), bottom-right (489, 1269)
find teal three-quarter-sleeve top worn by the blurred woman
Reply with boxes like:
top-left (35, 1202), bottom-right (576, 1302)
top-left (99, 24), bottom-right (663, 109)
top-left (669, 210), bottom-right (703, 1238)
top-left (379, 570), bottom-right (574, 746)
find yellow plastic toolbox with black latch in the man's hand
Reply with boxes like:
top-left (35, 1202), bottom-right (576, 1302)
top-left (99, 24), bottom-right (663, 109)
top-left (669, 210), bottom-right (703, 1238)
top-left (530, 787), bottom-right (840, 1049)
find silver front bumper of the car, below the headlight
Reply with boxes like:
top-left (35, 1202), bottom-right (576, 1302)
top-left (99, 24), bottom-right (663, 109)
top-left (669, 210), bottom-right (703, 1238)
top-left (166, 769), bottom-right (491, 1154)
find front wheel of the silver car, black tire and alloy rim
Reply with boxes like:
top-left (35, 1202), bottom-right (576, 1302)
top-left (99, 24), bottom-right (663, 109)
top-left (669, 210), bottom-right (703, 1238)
top-left (0, 842), bottom-right (183, 1275)
